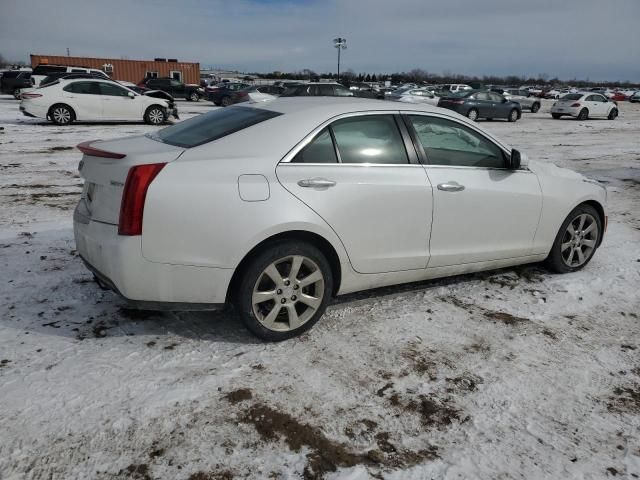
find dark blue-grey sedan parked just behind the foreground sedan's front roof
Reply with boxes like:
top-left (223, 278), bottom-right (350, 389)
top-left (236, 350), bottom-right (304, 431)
top-left (438, 90), bottom-right (522, 122)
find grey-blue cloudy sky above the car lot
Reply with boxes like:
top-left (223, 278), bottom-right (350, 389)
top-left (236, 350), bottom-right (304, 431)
top-left (0, 0), bottom-right (640, 82)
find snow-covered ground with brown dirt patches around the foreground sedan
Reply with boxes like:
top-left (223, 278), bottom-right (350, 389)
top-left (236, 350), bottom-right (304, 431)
top-left (0, 96), bottom-right (640, 480)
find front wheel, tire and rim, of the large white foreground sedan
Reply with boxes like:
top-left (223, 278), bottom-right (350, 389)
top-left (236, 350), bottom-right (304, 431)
top-left (546, 204), bottom-right (602, 273)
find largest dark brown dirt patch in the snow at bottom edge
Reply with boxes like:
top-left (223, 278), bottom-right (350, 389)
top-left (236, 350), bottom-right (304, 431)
top-left (242, 404), bottom-right (438, 480)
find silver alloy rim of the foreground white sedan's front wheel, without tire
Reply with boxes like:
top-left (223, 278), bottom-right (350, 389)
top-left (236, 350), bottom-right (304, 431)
top-left (560, 213), bottom-right (598, 268)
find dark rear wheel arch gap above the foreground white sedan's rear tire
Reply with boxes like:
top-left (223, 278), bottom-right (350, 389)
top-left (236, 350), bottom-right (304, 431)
top-left (226, 230), bottom-right (342, 302)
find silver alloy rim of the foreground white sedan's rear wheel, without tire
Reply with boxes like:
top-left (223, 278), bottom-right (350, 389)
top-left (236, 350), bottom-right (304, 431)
top-left (251, 255), bottom-right (324, 332)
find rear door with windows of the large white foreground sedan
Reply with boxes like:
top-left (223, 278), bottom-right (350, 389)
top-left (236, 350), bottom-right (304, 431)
top-left (276, 112), bottom-right (432, 273)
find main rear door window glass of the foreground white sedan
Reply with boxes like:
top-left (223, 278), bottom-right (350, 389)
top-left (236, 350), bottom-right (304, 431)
top-left (331, 115), bottom-right (409, 164)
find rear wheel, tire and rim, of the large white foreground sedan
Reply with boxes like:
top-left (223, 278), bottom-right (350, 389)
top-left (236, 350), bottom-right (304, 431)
top-left (231, 241), bottom-right (333, 342)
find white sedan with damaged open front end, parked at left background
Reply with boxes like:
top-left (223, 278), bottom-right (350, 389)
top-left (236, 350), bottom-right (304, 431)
top-left (20, 79), bottom-right (177, 125)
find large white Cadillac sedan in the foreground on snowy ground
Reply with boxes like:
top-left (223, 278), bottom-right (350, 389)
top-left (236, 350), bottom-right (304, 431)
top-left (74, 97), bottom-right (607, 340)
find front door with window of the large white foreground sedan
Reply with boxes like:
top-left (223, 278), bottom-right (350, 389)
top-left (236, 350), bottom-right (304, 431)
top-left (406, 112), bottom-right (542, 268)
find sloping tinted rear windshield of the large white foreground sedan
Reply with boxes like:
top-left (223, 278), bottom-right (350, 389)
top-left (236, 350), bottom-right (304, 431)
top-left (147, 107), bottom-right (282, 148)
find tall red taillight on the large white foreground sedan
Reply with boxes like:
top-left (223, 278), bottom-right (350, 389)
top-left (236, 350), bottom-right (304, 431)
top-left (118, 163), bottom-right (166, 235)
